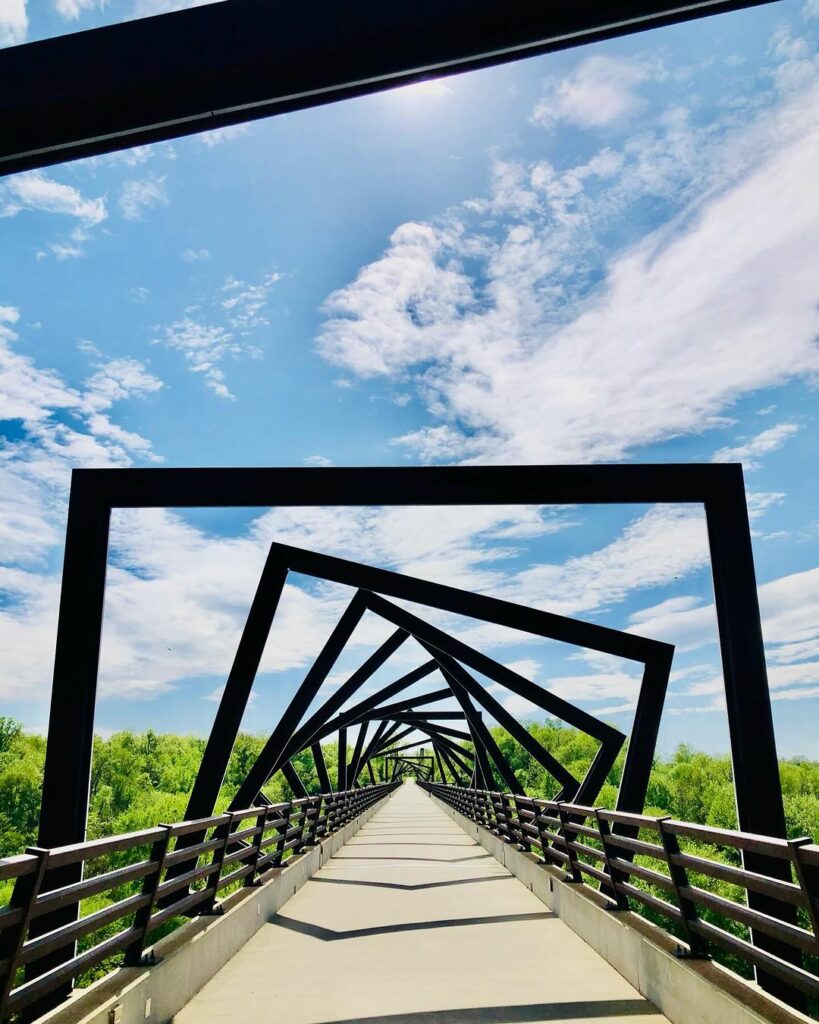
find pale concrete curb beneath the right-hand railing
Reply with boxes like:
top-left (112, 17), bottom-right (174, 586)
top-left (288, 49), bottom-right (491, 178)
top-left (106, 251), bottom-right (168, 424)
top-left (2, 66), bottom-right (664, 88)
top-left (430, 795), bottom-right (815, 1024)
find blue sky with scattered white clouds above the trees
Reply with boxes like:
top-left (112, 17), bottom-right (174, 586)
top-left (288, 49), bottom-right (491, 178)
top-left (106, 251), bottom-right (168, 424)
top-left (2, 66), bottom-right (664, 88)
top-left (0, 0), bottom-right (819, 758)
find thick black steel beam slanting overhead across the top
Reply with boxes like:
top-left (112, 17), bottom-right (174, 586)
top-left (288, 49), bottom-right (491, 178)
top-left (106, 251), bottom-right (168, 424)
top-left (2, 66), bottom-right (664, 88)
top-left (0, 0), bottom-right (768, 174)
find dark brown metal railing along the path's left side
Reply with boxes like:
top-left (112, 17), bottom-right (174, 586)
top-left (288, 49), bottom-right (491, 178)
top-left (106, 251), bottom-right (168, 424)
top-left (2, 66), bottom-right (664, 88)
top-left (0, 783), bottom-right (395, 1021)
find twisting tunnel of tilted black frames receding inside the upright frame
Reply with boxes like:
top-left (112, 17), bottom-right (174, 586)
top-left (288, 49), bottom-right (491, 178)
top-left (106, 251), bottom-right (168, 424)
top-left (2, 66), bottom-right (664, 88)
top-left (187, 543), bottom-right (674, 819)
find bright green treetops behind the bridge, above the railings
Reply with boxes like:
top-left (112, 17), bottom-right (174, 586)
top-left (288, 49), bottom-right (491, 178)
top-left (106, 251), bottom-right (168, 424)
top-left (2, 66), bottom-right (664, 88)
top-left (0, 717), bottom-right (819, 856)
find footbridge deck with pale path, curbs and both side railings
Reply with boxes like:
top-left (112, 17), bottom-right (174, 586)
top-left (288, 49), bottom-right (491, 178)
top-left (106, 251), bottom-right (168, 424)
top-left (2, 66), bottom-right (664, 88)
top-left (7, 782), bottom-right (819, 1024)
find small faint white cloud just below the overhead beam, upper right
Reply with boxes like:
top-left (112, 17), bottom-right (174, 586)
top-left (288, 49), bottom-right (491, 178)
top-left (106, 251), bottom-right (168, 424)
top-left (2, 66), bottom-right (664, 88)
top-left (532, 55), bottom-right (665, 128)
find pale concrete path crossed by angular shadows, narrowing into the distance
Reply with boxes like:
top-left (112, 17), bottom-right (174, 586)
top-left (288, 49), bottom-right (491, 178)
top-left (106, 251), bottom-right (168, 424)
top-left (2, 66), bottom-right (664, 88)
top-left (175, 784), bottom-right (666, 1024)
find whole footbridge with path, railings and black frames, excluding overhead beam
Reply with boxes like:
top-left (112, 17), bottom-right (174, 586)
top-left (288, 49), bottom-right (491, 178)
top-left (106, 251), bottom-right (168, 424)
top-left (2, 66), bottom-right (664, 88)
top-left (0, 465), bottom-right (819, 1024)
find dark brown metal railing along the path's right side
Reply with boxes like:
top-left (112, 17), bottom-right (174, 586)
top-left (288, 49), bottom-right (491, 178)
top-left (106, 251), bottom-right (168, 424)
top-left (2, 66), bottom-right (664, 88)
top-left (419, 782), bottom-right (819, 999)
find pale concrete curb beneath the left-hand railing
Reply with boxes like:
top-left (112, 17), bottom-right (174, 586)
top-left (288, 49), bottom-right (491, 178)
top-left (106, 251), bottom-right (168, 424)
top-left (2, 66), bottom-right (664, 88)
top-left (38, 795), bottom-right (391, 1024)
